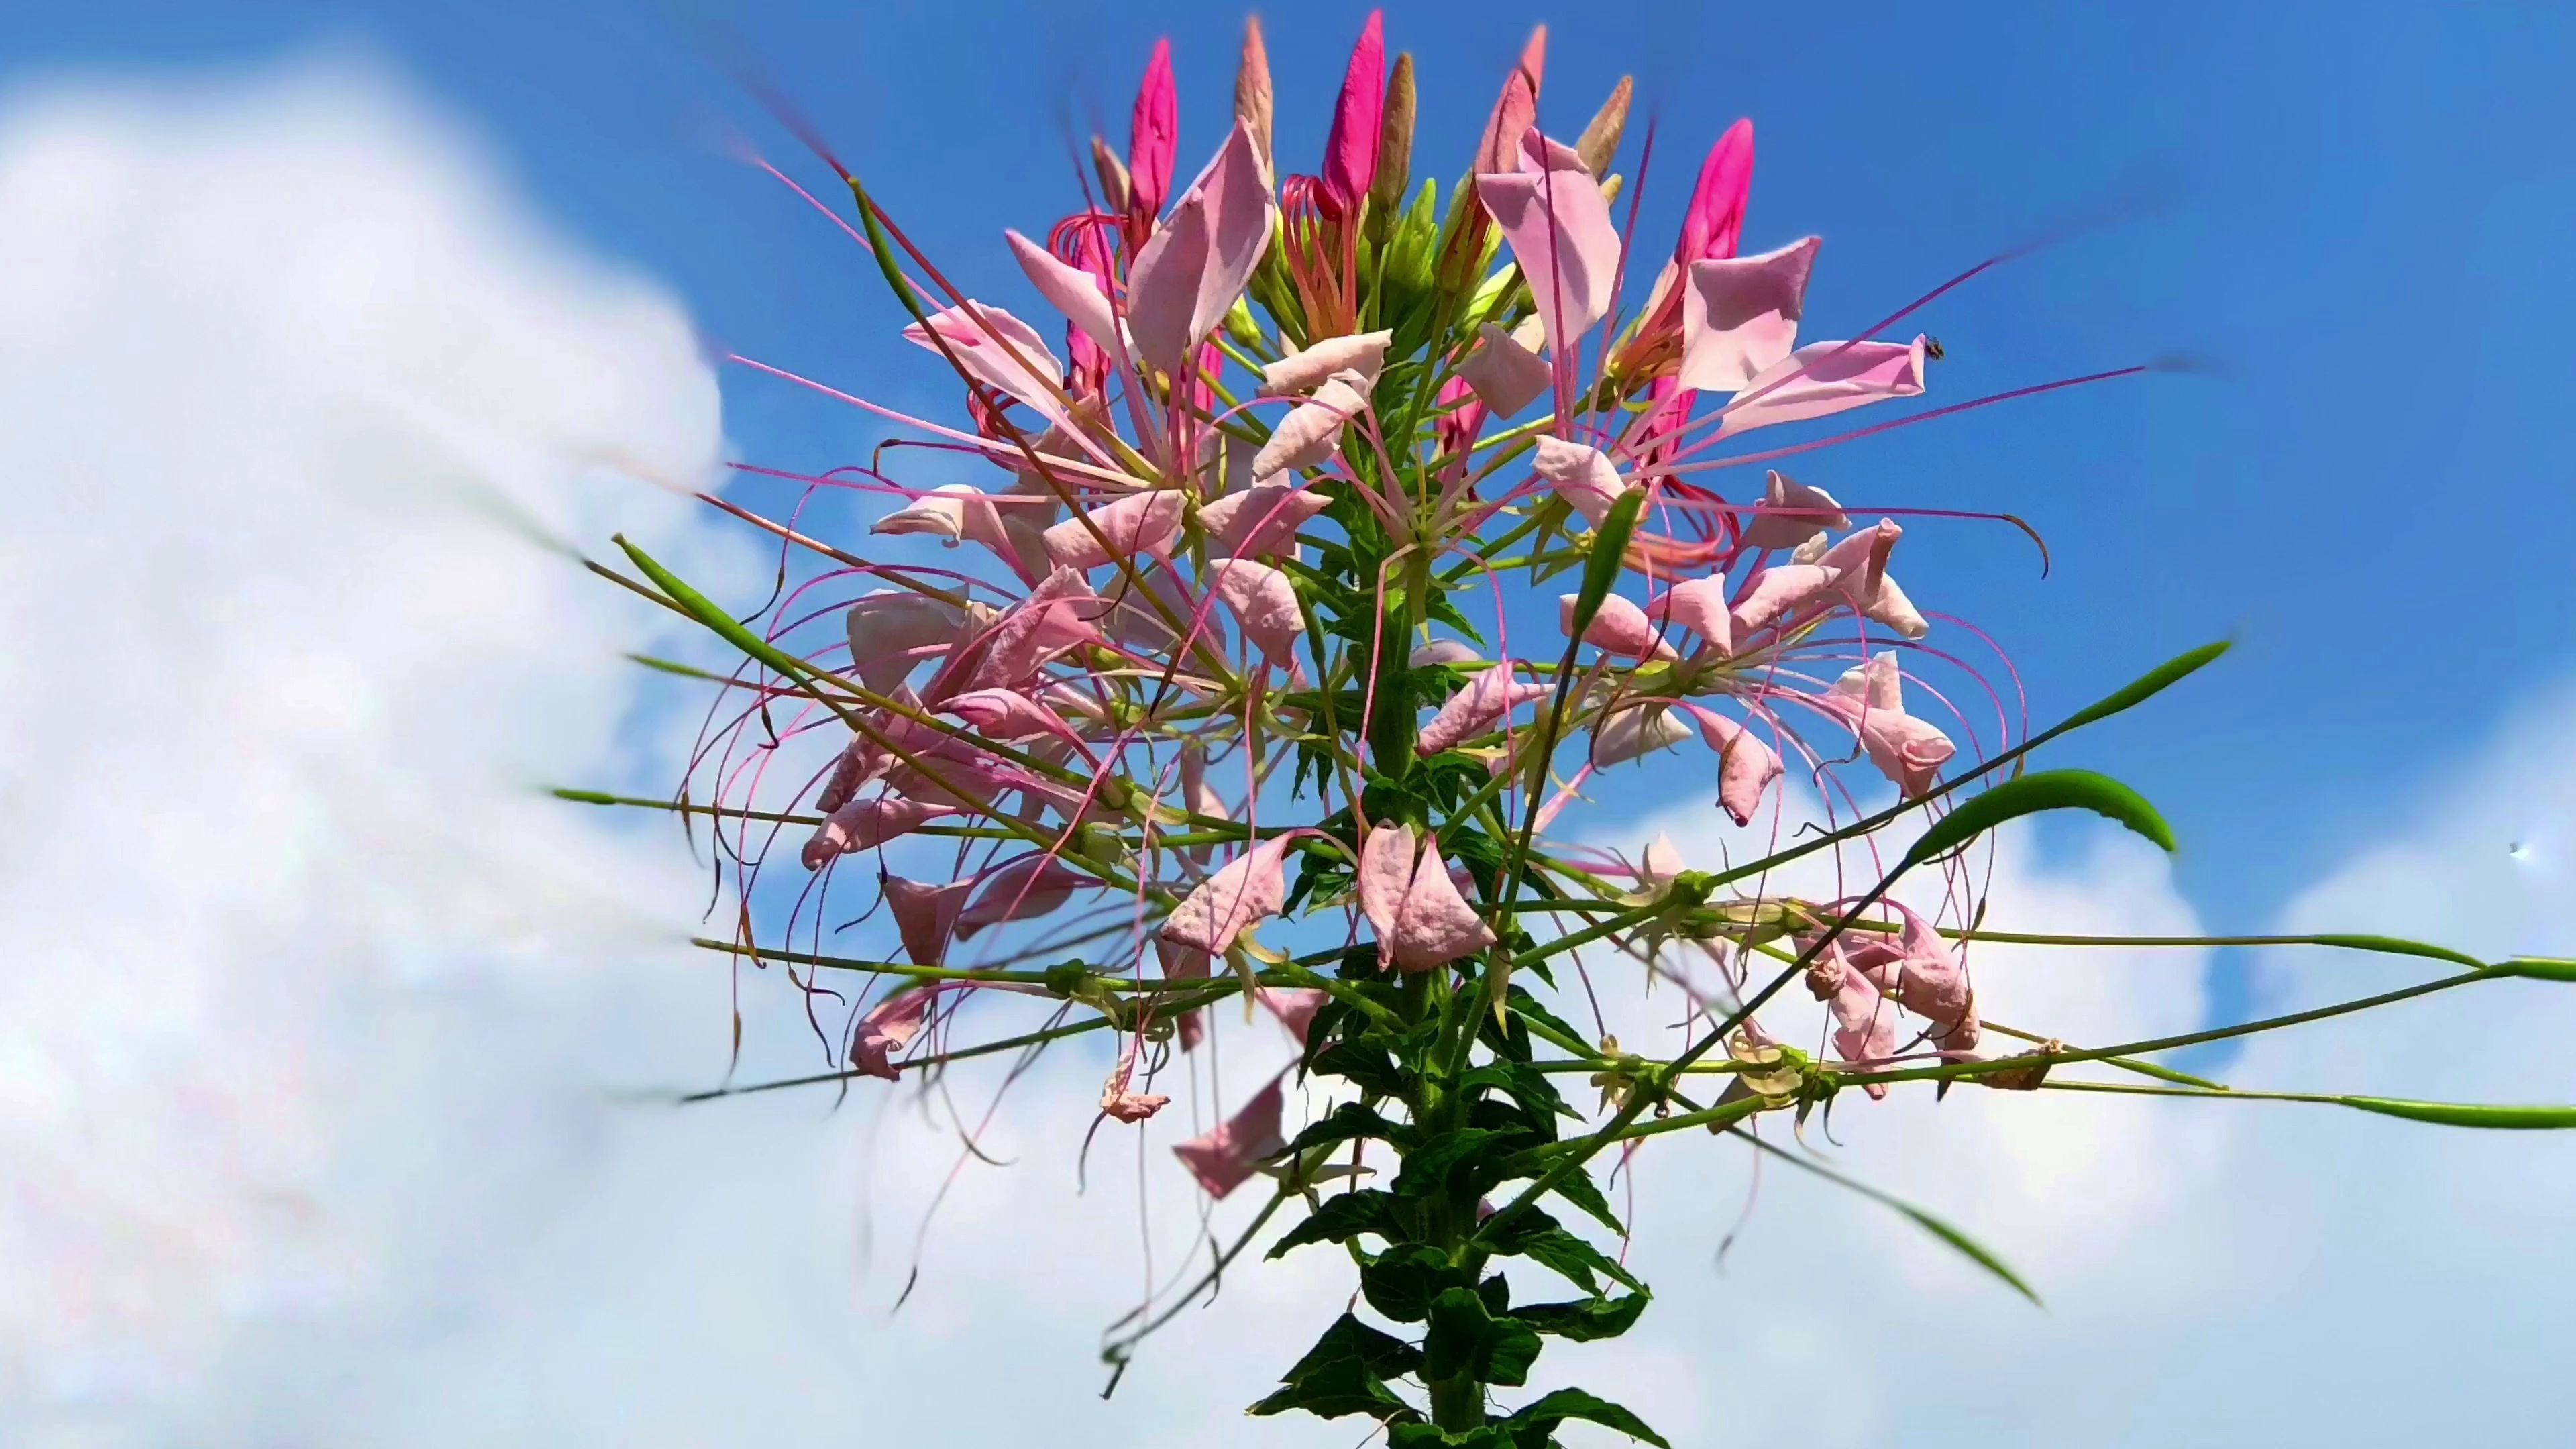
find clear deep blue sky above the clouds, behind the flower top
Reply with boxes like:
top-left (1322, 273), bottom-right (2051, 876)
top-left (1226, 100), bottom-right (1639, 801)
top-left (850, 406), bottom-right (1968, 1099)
top-left (15, 3), bottom-right (2576, 923)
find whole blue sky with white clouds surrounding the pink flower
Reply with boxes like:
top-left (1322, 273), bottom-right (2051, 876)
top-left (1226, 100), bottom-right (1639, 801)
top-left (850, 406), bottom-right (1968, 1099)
top-left (0, 3), bottom-right (2576, 1446)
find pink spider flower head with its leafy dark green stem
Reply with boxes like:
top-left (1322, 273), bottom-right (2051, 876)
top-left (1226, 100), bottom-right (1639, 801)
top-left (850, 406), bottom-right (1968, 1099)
top-left (590, 15), bottom-right (2576, 1444)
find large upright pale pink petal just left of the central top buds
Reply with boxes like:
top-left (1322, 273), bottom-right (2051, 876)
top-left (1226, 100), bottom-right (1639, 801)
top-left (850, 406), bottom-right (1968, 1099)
top-left (1128, 121), bottom-right (1273, 374)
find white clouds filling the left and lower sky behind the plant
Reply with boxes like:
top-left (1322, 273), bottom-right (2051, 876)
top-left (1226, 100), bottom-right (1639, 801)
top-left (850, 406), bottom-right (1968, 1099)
top-left (0, 50), bottom-right (2576, 1446)
